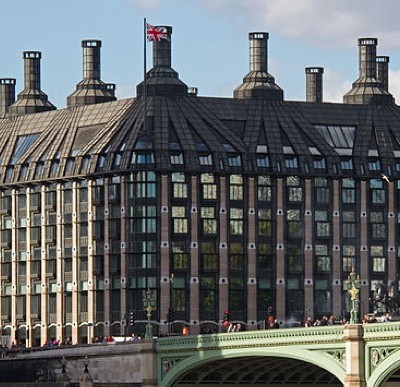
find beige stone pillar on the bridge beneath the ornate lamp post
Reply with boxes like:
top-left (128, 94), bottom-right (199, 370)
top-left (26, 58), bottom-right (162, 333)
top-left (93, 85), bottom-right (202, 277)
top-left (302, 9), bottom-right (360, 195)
top-left (343, 324), bottom-right (366, 387)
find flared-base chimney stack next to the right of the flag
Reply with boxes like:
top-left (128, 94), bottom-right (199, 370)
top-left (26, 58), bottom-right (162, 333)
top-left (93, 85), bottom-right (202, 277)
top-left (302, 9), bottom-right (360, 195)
top-left (233, 32), bottom-right (283, 101)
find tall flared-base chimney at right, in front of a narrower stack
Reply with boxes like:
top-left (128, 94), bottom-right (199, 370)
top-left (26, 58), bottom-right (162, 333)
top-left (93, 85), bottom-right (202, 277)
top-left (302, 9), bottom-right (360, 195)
top-left (343, 38), bottom-right (394, 105)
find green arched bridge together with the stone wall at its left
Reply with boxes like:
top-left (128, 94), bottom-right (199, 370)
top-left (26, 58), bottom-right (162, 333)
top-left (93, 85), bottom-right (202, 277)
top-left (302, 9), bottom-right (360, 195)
top-left (0, 322), bottom-right (400, 387)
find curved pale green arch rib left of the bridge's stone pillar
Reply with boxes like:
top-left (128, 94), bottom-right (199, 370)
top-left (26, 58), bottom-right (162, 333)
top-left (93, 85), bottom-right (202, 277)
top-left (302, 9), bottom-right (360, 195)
top-left (160, 346), bottom-right (345, 387)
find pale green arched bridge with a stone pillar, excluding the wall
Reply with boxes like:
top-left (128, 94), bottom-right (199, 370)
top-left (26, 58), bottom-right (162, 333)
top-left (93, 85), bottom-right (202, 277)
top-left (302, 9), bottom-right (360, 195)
top-left (156, 322), bottom-right (400, 387)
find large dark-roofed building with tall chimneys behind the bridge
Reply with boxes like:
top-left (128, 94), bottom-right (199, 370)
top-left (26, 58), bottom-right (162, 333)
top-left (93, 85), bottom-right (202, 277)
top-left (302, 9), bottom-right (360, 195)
top-left (0, 27), bottom-right (400, 345)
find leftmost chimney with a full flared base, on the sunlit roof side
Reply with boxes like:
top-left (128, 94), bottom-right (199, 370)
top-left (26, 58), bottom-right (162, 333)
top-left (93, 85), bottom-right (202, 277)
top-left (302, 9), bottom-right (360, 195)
top-left (9, 51), bottom-right (56, 116)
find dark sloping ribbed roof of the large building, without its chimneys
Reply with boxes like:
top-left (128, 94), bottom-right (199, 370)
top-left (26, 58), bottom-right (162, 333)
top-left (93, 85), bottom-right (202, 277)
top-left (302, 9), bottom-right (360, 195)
top-left (0, 95), bottom-right (400, 184)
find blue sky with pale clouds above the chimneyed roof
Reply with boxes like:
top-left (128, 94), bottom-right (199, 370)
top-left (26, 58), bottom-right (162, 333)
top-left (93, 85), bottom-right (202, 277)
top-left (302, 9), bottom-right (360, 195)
top-left (0, 0), bottom-right (400, 108)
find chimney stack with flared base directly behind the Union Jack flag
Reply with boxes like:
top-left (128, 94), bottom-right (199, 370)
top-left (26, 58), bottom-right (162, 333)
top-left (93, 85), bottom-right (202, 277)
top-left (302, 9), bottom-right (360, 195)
top-left (136, 26), bottom-right (188, 96)
